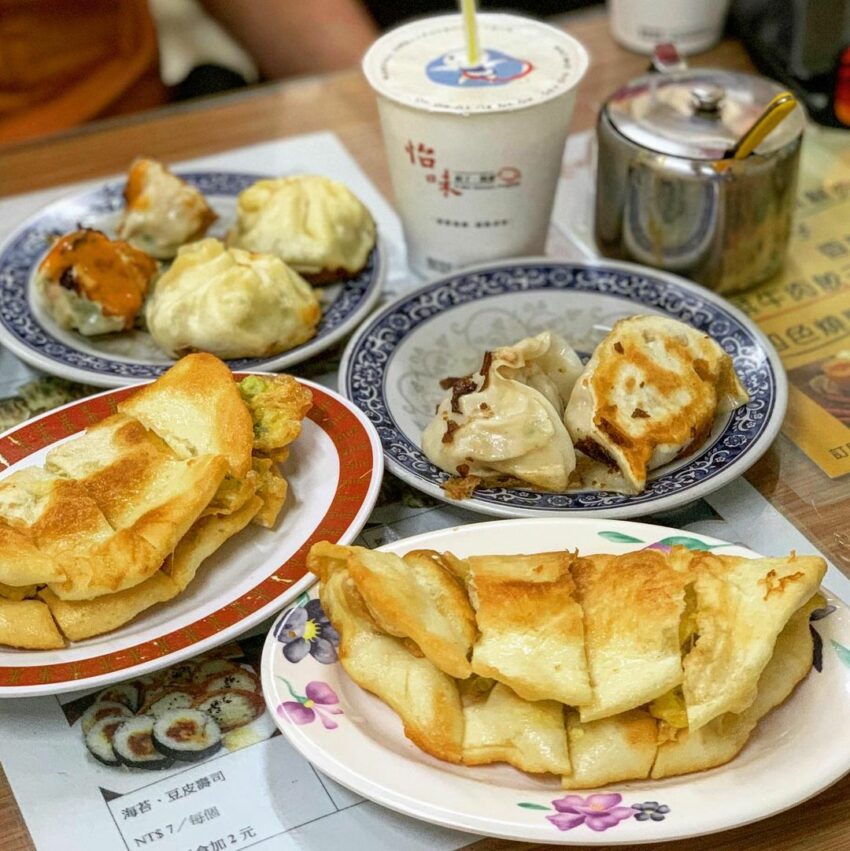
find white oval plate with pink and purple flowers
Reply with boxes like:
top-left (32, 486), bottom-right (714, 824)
top-left (261, 518), bottom-right (850, 845)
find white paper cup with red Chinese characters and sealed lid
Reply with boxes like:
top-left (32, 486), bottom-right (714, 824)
top-left (363, 14), bottom-right (587, 275)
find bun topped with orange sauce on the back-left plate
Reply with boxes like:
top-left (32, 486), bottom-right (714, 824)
top-left (35, 229), bottom-right (159, 337)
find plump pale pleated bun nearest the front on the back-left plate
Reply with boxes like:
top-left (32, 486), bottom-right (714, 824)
top-left (146, 239), bottom-right (321, 358)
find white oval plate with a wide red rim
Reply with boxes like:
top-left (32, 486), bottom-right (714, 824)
top-left (0, 379), bottom-right (383, 697)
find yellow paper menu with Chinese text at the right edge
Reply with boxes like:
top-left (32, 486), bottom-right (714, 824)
top-left (730, 127), bottom-right (850, 478)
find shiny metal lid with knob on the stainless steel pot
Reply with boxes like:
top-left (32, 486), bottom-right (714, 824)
top-left (605, 68), bottom-right (805, 160)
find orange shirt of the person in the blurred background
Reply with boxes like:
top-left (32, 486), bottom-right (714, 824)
top-left (0, 0), bottom-right (167, 143)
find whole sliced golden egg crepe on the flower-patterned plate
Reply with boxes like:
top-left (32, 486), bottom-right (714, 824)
top-left (308, 543), bottom-right (826, 789)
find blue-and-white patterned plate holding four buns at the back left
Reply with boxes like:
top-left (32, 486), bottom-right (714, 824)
top-left (0, 171), bottom-right (385, 387)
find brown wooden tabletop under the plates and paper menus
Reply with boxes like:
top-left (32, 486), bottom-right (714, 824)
top-left (0, 11), bottom-right (850, 851)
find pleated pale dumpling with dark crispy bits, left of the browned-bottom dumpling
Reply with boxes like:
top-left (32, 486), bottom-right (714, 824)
top-left (422, 331), bottom-right (582, 490)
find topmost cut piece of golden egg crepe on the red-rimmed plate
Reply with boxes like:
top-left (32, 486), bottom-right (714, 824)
top-left (118, 354), bottom-right (253, 479)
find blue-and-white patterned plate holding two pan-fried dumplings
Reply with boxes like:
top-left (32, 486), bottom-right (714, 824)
top-left (340, 258), bottom-right (788, 518)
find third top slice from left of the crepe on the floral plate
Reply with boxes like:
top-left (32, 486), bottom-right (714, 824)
top-left (571, 550), bottom-right (689, 721)
